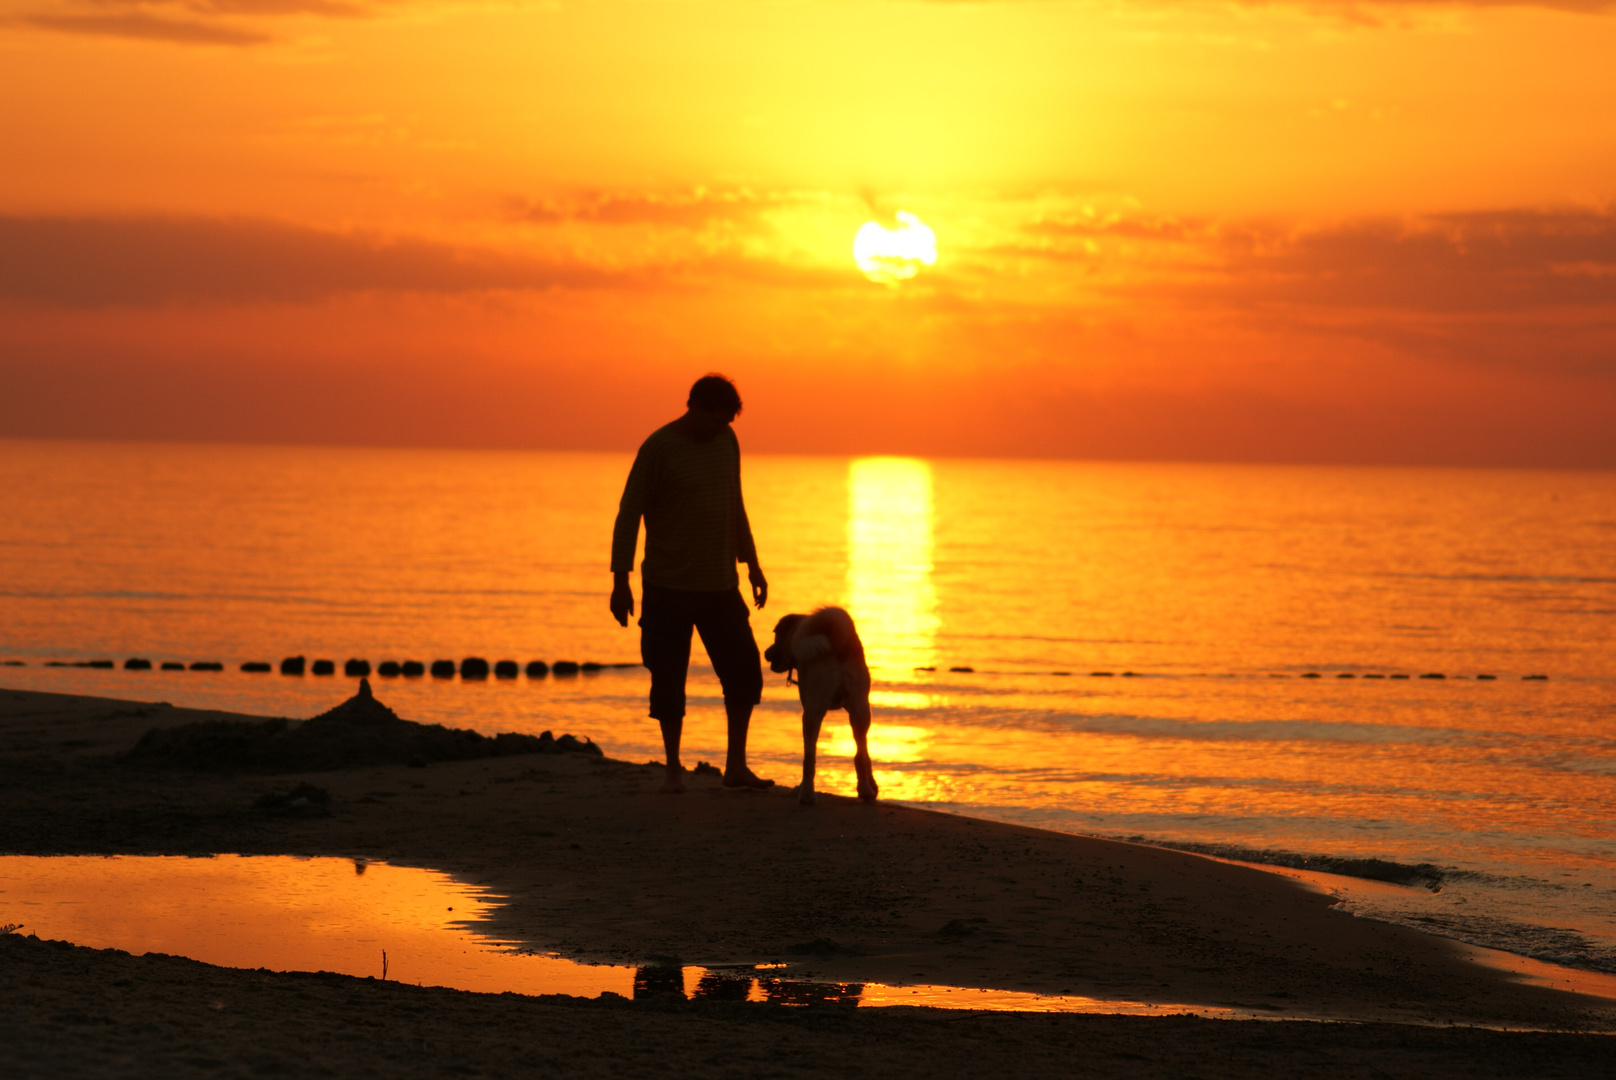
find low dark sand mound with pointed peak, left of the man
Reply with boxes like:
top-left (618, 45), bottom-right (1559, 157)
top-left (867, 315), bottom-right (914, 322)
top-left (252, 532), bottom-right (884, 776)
top-left (124, 679), bottom-right (601, 773)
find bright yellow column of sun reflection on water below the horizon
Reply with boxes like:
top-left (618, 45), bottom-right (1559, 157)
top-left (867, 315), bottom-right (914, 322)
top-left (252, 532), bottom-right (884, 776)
top-left (845, 458), bottom-right (941, 679)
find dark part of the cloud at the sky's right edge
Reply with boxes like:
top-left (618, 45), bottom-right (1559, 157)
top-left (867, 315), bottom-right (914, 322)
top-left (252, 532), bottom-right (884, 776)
top-left (1208, 210), bottom-right (1616, 378)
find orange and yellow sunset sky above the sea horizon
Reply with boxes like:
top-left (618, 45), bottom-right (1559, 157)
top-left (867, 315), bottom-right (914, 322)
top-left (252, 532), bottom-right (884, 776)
top-left (0, 0), bottom-right (1616, 467)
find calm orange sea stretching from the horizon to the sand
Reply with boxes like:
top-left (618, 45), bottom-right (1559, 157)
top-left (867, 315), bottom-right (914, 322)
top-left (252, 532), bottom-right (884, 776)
top-left (0, 430), bottom-right (1616, 972)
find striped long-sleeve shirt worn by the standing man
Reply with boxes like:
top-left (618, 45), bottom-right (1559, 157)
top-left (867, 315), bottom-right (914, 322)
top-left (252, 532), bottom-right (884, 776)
top-left (611, 422), bottom-right (758, 590)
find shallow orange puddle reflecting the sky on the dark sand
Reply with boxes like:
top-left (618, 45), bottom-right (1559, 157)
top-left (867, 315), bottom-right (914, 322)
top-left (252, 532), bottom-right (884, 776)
top-left (0, 855), bottom-right (1233, 1015)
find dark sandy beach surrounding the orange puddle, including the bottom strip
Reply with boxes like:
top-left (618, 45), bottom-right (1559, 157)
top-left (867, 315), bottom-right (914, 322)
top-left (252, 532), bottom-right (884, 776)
top-left (0, 690), bottom-right (1616, 1077)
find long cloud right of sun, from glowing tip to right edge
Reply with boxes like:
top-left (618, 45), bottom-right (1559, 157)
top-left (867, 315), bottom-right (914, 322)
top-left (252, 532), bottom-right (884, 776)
top-left (992, 209), bottom-right (1616, 377)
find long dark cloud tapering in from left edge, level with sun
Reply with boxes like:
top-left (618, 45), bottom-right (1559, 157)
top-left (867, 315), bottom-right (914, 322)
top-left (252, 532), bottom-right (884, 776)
top-left (0, 217), bottom-right (623, 307)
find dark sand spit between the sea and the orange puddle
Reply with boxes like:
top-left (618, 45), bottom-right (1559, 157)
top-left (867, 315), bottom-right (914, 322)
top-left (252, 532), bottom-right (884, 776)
top-left (0, 690), bottom-right (1616, 1073)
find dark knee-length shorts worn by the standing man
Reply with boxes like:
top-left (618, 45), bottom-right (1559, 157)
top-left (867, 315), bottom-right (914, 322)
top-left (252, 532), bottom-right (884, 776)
top-left (640, 584), bottom-right (763, 719)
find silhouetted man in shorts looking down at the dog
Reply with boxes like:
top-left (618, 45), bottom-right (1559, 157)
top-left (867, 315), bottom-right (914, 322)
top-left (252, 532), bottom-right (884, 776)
top-left (611, 375), bottom-right (774, 792)
